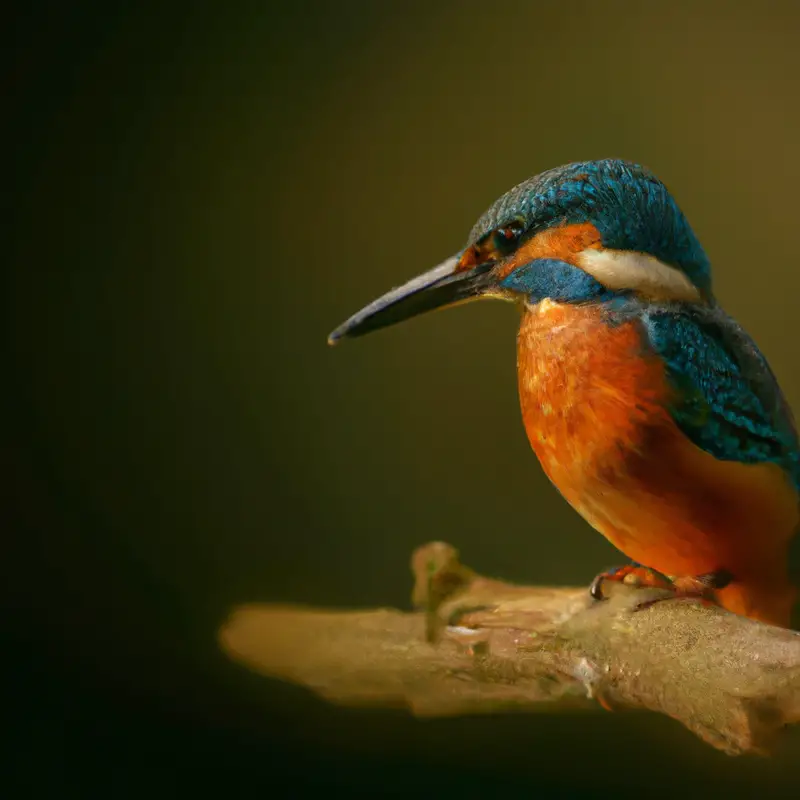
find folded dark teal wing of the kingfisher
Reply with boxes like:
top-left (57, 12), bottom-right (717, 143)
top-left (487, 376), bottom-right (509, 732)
top-left (642, 306), bottom-right (800, 487)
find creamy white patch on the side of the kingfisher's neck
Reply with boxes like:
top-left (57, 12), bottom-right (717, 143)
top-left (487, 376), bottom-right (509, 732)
top-left (577, 250), bottom-right (702, 303)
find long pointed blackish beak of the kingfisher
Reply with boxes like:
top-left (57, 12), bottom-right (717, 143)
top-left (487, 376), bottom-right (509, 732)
top-left (328, 256), bottom-right (494, 344)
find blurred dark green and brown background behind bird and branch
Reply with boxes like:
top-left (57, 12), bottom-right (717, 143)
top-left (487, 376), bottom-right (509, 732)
top-left (2, 0), bottom-right (800, 798)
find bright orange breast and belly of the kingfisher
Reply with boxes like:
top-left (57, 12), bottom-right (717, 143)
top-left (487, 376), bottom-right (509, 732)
top-left (518, 300), bottom-right (798, 624)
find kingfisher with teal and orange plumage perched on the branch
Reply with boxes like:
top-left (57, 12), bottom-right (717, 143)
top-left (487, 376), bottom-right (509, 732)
top-left (328, 159), bottom-right (800, 627)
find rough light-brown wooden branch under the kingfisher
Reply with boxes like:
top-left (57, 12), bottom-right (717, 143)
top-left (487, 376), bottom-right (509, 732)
top-left (219, 542), bottom-right (800, 754)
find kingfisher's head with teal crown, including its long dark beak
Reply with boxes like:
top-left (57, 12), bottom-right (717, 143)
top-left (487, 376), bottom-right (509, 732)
top-left (328, 159), bottom-right (712, 344)
